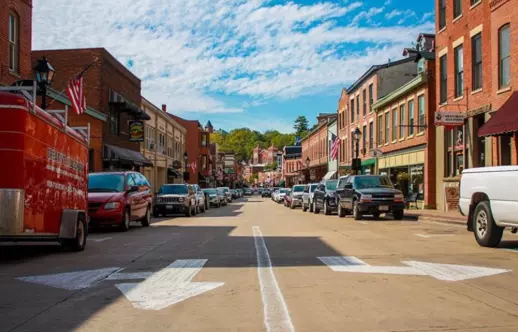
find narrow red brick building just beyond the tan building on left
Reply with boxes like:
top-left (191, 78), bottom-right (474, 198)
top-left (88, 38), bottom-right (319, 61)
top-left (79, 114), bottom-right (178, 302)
top-left (168, 113), bottom-right (213, 188)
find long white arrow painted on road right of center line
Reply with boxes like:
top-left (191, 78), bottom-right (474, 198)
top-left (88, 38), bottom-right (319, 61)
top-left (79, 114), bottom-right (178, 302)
top-left (318, 256), bottom-right (512, 281)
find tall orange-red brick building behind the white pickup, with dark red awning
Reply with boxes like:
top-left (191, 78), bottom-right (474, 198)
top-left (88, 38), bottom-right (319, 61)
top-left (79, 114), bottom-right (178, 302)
top-left (436, 0), bottom-right (518, 211)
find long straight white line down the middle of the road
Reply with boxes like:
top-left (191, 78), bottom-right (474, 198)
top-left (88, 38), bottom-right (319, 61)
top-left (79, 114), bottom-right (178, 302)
top-left (252, 226), bottom-right (295, 331)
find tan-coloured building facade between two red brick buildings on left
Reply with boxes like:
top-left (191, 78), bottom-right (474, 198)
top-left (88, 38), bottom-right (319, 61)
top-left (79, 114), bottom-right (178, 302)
top-left (141, 98), bottom-right (186, 192)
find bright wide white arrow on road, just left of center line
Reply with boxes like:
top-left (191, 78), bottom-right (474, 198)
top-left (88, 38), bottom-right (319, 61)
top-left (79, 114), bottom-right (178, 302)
top-left (115, 259), bottom-right (225, 310)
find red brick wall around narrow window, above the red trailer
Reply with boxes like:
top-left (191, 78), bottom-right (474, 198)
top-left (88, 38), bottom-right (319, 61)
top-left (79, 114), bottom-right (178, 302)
top-left (0, 0), bottom-right (33, 85)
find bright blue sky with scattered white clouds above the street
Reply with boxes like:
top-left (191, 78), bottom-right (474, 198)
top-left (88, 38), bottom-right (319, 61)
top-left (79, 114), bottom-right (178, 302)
top-left (33, 0), bottom-right (434, 133)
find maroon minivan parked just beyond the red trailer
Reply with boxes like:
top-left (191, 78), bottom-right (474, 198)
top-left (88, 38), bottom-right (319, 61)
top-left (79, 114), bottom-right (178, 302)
top-left (88, 171), bottom-right (152, 231)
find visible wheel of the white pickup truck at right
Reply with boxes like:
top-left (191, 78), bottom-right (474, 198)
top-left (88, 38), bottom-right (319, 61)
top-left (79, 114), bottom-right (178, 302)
top-left (472, 201), bottom-right (504, 247)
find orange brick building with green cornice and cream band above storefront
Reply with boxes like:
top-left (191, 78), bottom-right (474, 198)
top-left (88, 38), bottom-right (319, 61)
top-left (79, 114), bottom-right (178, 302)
top-left (372, 34), bottom-right (436, 208)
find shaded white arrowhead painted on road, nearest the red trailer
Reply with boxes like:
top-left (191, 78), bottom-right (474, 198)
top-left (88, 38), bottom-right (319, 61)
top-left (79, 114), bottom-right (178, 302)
top-left (16, 267), bottom-right (119, 290)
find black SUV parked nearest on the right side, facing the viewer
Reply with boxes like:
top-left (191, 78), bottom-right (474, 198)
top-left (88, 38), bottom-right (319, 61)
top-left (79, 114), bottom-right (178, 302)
top-left (336, 175), bottom-right (405, 220)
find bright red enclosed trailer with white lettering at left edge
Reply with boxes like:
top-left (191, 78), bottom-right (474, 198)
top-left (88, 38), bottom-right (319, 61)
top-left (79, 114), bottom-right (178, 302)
top-left (0, 87), bottom-right (89, 251)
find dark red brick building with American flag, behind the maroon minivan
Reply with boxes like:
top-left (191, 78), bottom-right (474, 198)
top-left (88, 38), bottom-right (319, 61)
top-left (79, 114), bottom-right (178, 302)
top-left (32, 48), bottom-right (152, 171)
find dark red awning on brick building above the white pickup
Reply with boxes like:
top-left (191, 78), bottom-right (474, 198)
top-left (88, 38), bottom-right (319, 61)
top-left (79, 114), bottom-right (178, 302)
top-left (478, 92), bottom-right (518, 137)
